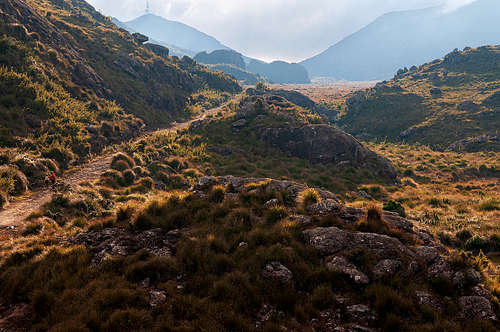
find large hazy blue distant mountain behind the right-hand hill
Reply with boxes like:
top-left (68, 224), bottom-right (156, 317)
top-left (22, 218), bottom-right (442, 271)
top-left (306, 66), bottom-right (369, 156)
top-left (302, 0), bottom-right (500, 81)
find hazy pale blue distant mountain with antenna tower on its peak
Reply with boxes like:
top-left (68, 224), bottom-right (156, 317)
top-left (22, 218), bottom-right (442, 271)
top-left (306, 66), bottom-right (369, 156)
top-left (123, 14), bottom-right (229, 53)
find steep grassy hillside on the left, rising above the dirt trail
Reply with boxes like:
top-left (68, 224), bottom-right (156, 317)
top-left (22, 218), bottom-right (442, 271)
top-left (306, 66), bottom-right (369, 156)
top-left (0, 0), bottom-right (241, 202)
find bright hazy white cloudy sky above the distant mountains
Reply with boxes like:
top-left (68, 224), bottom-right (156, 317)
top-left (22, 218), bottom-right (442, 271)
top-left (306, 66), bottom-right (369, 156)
top-left (87, 0), bottom-right (474, 61)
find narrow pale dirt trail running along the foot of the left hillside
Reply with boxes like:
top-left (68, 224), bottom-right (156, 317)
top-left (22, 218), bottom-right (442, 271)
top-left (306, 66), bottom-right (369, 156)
top-left (0, 107), bottom-right (221, 229)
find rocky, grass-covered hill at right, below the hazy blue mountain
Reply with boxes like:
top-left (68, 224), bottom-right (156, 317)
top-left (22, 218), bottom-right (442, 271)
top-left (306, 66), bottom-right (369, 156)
top-left (340, 46), bottom-right (500, 151)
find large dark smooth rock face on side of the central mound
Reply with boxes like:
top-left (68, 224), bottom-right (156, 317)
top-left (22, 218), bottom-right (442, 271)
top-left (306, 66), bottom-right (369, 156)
top-left (259, 125), bottom-right (397, 182)
